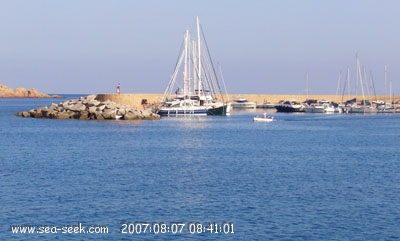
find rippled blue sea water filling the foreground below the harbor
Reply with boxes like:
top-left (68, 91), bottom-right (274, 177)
top-left (0, 95), bottom-right (400, 240)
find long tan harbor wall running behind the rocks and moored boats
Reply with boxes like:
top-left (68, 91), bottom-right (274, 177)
top-left (96, 93), bottom-right (400, 109)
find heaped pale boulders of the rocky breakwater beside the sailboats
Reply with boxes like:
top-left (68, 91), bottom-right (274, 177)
top-left (17, 95), bottom-right (160, 120)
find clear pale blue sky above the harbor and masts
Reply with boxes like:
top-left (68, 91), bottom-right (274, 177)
top-left (0, 0), bottom-right (400, 95)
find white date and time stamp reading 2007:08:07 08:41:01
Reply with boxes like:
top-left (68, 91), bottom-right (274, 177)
top-left (120, 222), bottom-right (235, 234)
